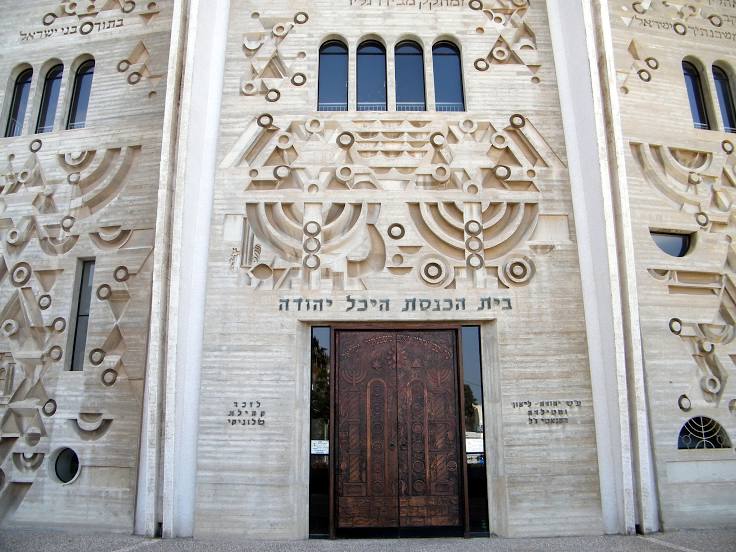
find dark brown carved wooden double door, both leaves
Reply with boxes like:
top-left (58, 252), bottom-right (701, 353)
top-left (334, 330), bottom-right (464, 529)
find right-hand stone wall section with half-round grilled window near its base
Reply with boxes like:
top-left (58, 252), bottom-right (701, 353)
top-left (610, 0), bottom-right (736, 528)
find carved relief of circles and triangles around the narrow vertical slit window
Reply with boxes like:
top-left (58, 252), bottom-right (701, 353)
top-left (0, 140), bottom-right (153, 521)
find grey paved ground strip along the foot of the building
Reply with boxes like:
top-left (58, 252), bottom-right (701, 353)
top-left (0, 530), bottom-right (736, 552)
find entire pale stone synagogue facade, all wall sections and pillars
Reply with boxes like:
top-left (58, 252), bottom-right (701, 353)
top-left (0, 0), bottom-right (736, 539)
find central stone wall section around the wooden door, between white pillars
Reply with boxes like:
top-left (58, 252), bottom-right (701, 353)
top-left (195, 0), bottom-right (602, 538)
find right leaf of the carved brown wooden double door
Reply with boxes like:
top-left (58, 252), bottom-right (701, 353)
top-left (396, 331), bottom-right (462, 527)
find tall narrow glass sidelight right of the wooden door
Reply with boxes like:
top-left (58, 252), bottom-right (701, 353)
top-left (462, 326), bottom-right (489, 535)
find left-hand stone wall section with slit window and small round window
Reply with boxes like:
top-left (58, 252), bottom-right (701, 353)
top-left (0, 0), bottom-right (173, 532)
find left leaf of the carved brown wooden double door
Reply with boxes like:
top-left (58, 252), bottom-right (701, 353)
top-left (335, 331), bottom-right (399, 529)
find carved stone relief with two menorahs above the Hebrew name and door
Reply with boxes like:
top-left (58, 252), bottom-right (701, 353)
top-left (221, 114), bottom-right (569, 290)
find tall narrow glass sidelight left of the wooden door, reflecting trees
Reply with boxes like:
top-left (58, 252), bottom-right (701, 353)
top-left (309, 327), bottom-right (330, 536)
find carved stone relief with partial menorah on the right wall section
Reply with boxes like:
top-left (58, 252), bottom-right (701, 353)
top-left (632, 142), bottom-right (736, 409)
